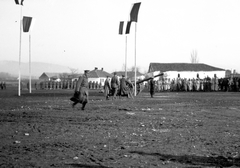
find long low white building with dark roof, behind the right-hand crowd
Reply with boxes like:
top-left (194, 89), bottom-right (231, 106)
top-left (148, 63), bottom-right (226, 79)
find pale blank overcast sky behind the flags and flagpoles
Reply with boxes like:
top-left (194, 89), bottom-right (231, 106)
top-left (0, 0), bottom-right (240, 72)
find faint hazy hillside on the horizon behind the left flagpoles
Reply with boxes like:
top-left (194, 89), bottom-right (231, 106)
top-left (0, 61), bottom-right (70, 78)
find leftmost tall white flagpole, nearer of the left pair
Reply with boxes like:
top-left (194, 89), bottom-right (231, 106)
top-left (18, 5), bottom-right (22, 96)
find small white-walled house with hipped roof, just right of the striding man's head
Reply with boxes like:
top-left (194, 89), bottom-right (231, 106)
top-left (88, 67), bottom-right (112, 86)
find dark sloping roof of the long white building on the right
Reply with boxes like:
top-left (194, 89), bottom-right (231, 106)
top-left (148, 63), bottom-right (225, 72)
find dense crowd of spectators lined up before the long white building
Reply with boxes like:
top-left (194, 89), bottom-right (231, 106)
top-left (152, 77), bottom-right (240, 92)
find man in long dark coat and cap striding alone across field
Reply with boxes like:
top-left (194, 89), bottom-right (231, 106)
top-left (70, 70), bottom-right (89, 110)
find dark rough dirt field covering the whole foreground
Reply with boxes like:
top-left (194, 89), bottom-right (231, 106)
top-left (0, 89), bottom-right (240, 168)
